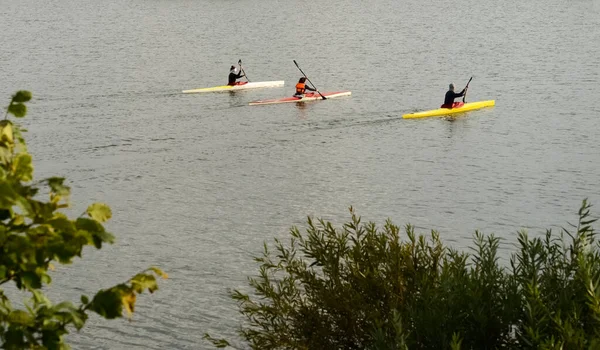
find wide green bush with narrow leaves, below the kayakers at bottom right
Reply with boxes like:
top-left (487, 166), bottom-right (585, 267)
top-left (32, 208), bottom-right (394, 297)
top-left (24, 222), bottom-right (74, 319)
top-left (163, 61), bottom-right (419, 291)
top-left (210, 201), bottom-right (600, 350)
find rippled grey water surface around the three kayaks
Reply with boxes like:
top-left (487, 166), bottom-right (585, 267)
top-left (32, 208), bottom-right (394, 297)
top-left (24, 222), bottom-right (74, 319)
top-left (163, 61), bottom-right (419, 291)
top-left (0, 0), bottom-right (600, 349)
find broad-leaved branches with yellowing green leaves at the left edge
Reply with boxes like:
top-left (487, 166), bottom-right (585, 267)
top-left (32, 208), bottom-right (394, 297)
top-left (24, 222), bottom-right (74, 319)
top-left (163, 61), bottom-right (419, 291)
top-left (0, 91), bottom-right (167, 349)
